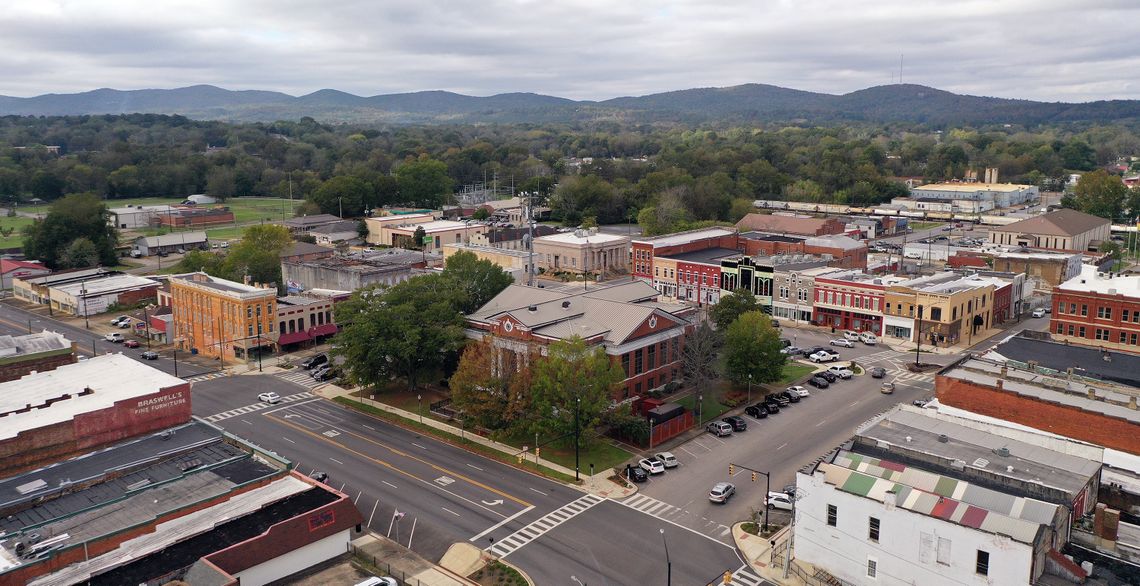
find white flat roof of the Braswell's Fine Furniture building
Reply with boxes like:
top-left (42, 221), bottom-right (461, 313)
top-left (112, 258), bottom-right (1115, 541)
top-left (0, 353), bottom-right (189, 440)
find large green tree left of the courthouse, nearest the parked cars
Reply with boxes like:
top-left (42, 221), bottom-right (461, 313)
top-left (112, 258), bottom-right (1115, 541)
top-left (333, 275), bottom-right (465, 390)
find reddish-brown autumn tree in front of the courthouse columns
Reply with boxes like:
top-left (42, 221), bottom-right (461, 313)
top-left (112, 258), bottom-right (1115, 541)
top-left (448, 336), bottom-right (537, 430)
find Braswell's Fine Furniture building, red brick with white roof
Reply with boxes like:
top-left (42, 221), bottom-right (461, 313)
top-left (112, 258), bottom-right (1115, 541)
top-left (0, 355), bottom-right (190, 475)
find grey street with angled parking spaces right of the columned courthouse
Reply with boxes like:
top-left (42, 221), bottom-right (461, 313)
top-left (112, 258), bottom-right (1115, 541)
top-left (625, 327), bottom-right (953, 540)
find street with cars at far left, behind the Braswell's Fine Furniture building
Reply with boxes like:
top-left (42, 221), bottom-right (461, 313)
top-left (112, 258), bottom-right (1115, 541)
top-left (0, 301), bottom-right (219, 379)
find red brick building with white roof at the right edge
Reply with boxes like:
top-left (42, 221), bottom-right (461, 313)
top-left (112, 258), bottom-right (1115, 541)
top-left (1049, 264), bottom-right (1140, 353)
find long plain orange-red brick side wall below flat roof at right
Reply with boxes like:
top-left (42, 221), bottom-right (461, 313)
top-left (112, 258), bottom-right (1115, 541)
top-left (935, 376), bottom-right (1140, 455)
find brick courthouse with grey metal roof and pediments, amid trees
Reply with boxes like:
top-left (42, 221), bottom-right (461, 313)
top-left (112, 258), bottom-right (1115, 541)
top-left (467, 280), bottom-right (693, 401)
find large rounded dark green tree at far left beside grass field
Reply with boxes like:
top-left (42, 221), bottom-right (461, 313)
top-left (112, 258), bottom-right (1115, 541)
top-left (24, 194), bottom-right (119, 269)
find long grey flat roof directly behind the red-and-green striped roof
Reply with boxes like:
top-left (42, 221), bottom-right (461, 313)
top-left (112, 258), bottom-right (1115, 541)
top-left (854, 409), bottom-right (1100, 497)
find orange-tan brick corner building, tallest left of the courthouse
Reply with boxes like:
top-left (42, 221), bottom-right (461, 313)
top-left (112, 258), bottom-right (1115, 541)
top-left (170, 272), bottom-right (277, 359)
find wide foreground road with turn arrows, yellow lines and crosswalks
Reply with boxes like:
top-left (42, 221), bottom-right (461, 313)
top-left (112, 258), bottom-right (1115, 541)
top-left (194, 373), bottom-right (775, 585)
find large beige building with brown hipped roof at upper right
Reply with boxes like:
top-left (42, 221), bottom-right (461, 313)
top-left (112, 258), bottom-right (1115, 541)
top-left (990, 209), bottom-right (1112, 252)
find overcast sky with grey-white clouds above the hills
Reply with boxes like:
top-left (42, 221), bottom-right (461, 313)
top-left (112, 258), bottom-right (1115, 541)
top-left (0, 0), bottom-right (1140, 101)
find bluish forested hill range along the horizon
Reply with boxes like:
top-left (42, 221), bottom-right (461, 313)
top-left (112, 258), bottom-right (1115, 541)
top-left (0, 83), bottom-right (1140, 124)
